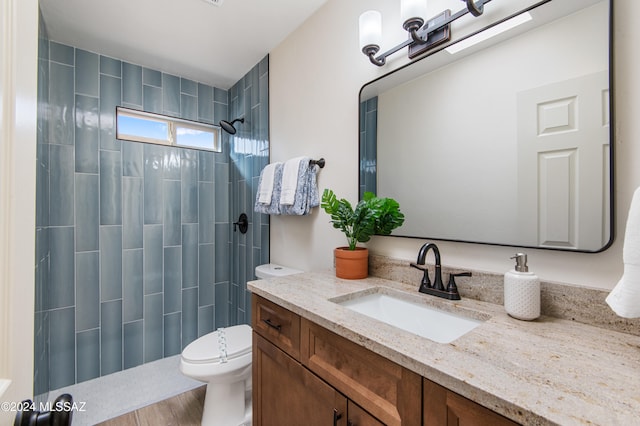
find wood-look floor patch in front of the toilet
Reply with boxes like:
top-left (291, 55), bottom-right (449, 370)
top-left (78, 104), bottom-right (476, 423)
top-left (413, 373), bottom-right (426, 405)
top-left (99, 386), bottom-right (206, 426)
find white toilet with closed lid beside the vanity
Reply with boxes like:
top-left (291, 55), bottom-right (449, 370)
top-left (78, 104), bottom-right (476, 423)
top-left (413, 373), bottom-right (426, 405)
top-left (180, 263), bottom-right (302, 426)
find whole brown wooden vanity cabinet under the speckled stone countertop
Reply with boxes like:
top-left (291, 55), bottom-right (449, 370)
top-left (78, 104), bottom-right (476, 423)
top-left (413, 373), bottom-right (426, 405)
top-left (252, 294), bottom-right (517, 426)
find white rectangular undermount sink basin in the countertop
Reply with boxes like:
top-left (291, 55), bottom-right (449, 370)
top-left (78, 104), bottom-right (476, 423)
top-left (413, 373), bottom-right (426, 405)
top-left (337, 293), bottom-right (482, 343)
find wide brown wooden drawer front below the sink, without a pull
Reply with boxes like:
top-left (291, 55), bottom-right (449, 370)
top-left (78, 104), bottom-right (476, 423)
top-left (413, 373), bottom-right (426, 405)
top-left (300, 318), bottom-right (422, 426)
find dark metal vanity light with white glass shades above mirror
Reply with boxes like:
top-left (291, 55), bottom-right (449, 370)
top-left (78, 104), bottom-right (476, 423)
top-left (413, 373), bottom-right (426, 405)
top-left (359, 0), bottom-right (491, 67)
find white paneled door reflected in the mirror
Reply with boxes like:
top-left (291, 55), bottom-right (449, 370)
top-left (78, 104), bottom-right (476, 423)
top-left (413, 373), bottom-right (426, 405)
top-left (517, 71), bottom-right (611, 250)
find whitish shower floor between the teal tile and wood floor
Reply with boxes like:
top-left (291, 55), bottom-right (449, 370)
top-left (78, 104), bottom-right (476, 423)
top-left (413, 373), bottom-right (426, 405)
top-left (49, 355), bottom-right (203, 426)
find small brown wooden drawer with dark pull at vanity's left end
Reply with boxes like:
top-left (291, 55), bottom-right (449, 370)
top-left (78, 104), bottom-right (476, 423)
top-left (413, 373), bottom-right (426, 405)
top-left (251, 294), bottom-right (300, 360)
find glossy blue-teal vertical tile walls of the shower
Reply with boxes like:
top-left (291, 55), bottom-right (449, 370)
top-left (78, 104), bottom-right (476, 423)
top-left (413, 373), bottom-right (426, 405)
top-left (34, 32), bottom-right (268, 395)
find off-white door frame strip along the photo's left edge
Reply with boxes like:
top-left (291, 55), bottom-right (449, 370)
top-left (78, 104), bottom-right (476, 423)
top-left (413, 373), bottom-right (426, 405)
top-left (0, 0), bottom-right (38, 425)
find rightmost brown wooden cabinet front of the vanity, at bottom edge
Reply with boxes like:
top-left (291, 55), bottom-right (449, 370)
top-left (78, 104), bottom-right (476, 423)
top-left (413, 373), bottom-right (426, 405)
top-left (422, 379), bottom-right (518, 426)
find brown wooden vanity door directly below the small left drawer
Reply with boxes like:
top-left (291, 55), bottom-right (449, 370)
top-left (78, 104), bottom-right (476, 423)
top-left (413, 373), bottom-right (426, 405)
top-left (253, 332), bottom-right (347, 426)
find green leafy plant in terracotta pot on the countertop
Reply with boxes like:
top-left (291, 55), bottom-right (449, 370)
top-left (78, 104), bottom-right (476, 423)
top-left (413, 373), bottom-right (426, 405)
top-left (320, 189), bottom-right (404, 279)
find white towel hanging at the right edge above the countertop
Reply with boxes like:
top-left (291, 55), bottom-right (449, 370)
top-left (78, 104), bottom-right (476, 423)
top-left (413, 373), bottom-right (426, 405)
top-left (606, 188), bottom-right (640, 318)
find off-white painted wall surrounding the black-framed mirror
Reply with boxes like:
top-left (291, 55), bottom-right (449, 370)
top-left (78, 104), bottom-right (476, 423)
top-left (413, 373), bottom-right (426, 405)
top-left (270, 0), bottom-right (640, 289)
